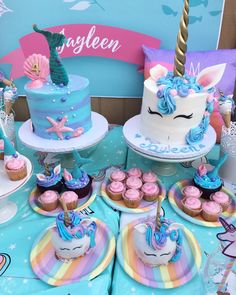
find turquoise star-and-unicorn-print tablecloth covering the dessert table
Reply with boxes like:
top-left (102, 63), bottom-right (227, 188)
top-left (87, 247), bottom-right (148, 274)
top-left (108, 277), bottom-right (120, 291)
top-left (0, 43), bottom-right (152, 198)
top-left (0, 123), bottom-right (236, 295)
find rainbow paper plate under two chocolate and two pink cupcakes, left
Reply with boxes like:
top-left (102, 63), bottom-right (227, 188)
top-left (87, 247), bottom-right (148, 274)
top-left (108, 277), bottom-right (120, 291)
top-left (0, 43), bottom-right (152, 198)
top-left (29, 187), bottom-right (96, 217)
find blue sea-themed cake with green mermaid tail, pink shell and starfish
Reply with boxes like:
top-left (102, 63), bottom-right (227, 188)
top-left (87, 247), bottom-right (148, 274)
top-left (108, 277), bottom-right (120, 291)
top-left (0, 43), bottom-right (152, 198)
top-left (24, 25), bottom-right (92, 140)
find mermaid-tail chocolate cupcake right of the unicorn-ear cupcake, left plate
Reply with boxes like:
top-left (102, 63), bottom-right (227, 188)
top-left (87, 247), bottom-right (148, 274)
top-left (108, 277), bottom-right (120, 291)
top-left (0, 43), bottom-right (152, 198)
top-left (63, 151), bottom-right (92, 198)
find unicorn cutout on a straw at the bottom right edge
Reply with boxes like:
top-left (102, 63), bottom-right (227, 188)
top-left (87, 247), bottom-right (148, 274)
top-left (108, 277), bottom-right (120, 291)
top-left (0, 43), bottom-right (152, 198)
top-left (216, 217), bottom-right (236, 295)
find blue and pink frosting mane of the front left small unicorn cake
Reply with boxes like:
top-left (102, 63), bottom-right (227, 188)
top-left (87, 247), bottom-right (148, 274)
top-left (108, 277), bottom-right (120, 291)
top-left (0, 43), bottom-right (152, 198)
top-left (56, 211), bottom-right (97, 248)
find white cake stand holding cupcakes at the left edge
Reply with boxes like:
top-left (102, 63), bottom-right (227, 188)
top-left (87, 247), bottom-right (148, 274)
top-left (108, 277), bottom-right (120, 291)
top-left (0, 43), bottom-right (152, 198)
top-left (0, 155), bottom-right (33, 224)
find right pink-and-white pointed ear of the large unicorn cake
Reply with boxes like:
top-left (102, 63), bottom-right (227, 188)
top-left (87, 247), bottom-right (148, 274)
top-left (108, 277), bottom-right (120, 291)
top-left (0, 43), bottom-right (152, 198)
top-left (196, 63), bottom-right (226, 90)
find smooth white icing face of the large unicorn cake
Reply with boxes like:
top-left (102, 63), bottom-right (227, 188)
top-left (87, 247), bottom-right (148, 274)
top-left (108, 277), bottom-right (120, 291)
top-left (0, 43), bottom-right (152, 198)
top-left (140, 78), bottom-right (208, 145)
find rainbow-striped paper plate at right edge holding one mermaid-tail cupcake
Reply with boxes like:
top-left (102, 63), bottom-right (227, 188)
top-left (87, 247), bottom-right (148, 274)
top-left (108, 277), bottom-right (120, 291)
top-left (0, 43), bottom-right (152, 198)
top-left (168, 179), bottom-right (236, 227)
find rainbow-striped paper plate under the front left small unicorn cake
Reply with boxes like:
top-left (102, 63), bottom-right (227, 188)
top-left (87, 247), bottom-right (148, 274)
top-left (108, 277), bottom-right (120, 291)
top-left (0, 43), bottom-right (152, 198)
top-left (30, 218), bottom-right (115, 286)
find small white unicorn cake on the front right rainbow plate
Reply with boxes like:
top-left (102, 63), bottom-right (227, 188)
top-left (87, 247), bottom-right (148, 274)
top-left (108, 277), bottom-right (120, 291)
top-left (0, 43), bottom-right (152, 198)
top-left (134, 195), bottom-right (183, 267)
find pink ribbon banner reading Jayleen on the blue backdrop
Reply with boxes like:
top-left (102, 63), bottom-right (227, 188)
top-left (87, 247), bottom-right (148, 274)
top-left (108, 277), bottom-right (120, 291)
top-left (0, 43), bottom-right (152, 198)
top-left (0, 24), bottom-right (160, 79)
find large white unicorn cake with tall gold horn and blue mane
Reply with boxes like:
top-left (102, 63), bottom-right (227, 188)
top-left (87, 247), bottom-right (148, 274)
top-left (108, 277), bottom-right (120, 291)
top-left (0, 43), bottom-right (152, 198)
top-left (140, 0), bottom-right (226, 147)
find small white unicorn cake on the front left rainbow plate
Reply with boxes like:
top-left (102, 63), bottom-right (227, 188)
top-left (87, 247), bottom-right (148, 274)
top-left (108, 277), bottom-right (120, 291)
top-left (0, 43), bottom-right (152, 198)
top-left (51, 200), bottom-right (97, 262)
